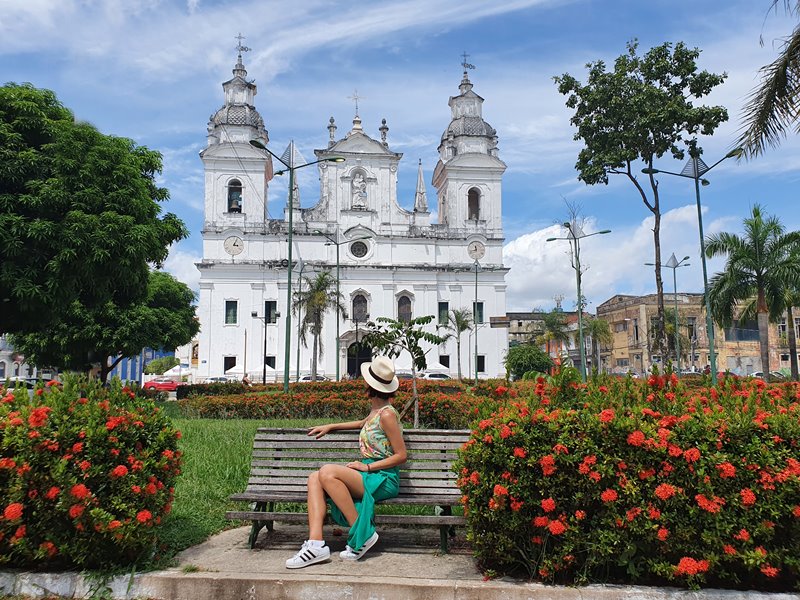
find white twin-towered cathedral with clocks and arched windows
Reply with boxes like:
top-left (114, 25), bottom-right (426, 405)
top-left (195, 47), bottom-right (508, 382)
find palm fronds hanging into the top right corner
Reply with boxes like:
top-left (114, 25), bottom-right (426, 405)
top-left (737, 0), bottom-right (800, 157)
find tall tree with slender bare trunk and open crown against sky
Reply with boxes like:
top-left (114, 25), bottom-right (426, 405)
top-left (555, 41), bottom-right (728, 356)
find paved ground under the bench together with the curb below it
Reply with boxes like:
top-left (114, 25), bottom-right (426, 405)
top-left (0, 524), bottom-right (800, 600)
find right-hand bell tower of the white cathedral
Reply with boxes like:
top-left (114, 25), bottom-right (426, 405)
top-left (433, 61), bottom-right (506, 238)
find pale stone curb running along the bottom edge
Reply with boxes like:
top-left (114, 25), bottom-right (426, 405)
top-left (0, 570), bottom-right (800, 600)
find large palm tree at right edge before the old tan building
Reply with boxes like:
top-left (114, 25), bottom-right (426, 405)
top-left (706, 205), bottom-right (800, 377)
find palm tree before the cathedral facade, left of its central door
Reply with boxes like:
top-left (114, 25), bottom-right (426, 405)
top-left (292, 271), bottom-right (347, 381)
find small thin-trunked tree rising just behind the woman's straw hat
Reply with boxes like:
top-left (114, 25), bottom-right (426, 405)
top-left (363, 315), bottom-right (444, 427)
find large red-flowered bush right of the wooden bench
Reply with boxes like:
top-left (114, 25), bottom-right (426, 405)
top-left (455, 375), bottom-right (800, 589)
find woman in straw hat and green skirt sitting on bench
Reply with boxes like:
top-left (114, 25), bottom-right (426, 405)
top-left (286, 356), bottom-right (406, 569)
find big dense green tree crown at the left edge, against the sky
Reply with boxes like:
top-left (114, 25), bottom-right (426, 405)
top-left (0, 83), bottom-right (187, 333)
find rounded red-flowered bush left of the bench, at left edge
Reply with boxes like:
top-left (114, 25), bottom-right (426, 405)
top-left (0, 379), bottom-right (180, 568)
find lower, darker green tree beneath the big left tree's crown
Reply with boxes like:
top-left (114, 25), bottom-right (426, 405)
top-left (11, 271), bottom-right (200, 381)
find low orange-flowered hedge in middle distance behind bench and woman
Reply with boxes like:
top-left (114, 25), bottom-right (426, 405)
top-left (178, 379), bottom-right (482, 429)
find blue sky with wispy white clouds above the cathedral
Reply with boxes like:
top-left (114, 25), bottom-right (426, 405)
top-left (0, 0), bottom-right (800, 310)
